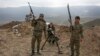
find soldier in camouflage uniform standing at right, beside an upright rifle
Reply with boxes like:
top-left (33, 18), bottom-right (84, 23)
top-left (70, 16), bottom-right (83, 56)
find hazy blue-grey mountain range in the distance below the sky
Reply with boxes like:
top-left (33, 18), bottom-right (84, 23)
top-left (0, 6), bottom-right (100, 24)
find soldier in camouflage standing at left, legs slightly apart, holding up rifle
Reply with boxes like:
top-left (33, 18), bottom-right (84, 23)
top-left (31, 14), bottom-right (46, 55)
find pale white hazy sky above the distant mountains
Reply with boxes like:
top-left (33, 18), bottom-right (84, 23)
top-left (0, 0), bottom-right (100, 7)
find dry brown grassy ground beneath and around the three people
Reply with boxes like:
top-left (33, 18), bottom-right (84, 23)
top-left (0, 22), bottom-right (100, 56)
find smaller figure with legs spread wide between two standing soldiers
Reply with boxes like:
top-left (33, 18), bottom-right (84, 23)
top-left (41, 23), bottom-right (62, 54)
